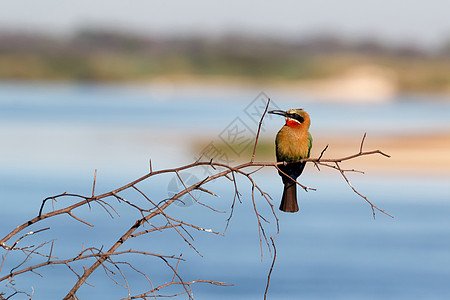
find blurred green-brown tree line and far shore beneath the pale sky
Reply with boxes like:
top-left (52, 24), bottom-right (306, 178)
top-left (0, 29), bottom-right (450, 93)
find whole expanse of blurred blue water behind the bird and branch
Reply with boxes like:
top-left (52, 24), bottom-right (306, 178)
top-left (0, 82), bottom-right (450, 299)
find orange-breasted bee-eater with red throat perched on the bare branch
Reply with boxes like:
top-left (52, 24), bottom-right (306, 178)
top-left (268, 108), bottom-right (313, 212)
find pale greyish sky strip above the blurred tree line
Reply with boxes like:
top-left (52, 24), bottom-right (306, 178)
top-left (0, 0), bottom-right (450, 46)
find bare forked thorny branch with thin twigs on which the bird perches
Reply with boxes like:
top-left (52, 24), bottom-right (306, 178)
top-left (0, 99), bottom-right (392, 299)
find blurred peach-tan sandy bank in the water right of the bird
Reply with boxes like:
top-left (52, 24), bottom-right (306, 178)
top-left (312, 133), bottom-right (450, 177)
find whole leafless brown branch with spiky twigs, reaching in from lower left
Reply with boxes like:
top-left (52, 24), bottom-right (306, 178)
top-left (0, 99), bottom-right (392, 299)
